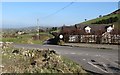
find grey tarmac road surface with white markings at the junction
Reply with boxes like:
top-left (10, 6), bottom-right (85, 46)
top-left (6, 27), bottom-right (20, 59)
top-left (14, 44), bottom-right (120, 73)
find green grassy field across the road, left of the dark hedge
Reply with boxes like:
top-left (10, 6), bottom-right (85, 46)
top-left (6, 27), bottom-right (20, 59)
top-left (0, 33), bottom-right (53, 44)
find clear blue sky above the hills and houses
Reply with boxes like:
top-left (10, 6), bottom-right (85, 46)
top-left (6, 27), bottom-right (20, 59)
top-left (0, 2), bottom-right (118, 28)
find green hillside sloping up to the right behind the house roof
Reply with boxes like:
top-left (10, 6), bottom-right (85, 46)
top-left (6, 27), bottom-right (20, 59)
top-left (80, 9), bottom-right (120, 28)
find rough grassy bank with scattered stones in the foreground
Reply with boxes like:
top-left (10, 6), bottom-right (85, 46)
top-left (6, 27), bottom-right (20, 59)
top-left (0, 44), bottom-right (87, 75)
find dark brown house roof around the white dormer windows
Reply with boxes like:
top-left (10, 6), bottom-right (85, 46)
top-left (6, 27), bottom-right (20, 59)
top-left (62, 24), bottom-right (116, 35)
